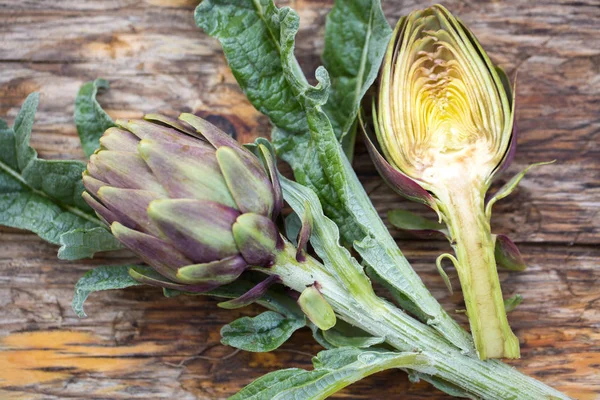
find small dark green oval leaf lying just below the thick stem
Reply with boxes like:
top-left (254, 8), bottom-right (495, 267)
top-left (221, 311), bottom-right (306, 352)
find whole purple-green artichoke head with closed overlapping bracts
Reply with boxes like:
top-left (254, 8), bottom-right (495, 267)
top-left (83, 114), bottom-right (283, 292)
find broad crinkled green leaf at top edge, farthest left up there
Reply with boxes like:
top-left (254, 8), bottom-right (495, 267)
top-left (195, 0), bottom-right (307, 136)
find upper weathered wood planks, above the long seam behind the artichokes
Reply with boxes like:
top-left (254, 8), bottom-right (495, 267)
top-left (0, 1), bottom-right (600, 243)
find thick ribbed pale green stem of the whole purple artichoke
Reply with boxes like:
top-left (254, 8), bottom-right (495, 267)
top-left (260, 244), bottom-right (568, 400)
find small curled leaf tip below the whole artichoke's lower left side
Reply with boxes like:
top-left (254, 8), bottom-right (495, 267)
top-left (72, 265), bottom-right (144, 318)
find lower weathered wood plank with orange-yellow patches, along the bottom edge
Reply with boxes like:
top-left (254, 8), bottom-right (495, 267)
top-left (0, 233), bottom-right (600, 399)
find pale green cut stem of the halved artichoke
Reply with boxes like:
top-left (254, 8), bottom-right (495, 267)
top-left (441, 184), bottom-right (520, 360)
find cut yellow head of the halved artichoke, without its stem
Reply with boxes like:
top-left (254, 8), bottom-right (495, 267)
top-left (376, 6), bottom-right (513, 193)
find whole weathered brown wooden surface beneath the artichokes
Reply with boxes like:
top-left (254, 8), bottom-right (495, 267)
top-left (0, 0), bottom-right (600, 399)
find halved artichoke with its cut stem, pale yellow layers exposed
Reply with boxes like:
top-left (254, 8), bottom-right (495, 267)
top-left (369, 5), bottom-right (519, 359)
